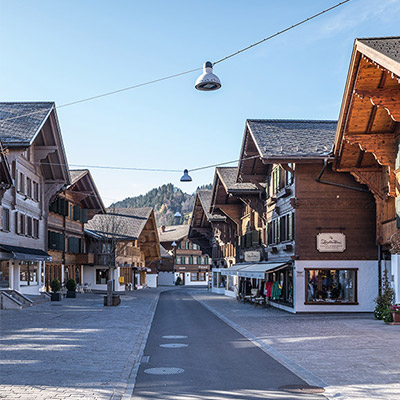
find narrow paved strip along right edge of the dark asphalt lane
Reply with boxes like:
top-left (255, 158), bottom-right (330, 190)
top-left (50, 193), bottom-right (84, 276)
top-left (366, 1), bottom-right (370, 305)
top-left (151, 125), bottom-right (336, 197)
top-left (191, 293), bottom-right (346, 400)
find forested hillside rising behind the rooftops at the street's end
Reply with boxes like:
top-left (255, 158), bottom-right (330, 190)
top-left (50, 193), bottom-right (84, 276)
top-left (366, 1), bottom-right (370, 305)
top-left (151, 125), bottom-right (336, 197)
top-left (111, 183), bottom-right (212, 226)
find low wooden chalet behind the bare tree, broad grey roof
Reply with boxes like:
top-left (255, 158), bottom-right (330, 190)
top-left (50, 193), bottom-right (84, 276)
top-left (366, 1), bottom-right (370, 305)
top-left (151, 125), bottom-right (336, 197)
top-left (83, 207), bottom-right (160, 291)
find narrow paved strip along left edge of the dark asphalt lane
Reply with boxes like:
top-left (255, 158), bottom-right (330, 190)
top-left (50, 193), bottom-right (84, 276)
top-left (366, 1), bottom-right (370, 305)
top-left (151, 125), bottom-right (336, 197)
top-left (111, 292), bottom-right (161, 400)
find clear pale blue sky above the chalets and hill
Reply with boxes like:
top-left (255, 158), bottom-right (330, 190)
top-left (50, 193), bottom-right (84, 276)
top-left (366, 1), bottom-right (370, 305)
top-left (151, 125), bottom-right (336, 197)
top-left (0, 0), bottom-right (400, 204)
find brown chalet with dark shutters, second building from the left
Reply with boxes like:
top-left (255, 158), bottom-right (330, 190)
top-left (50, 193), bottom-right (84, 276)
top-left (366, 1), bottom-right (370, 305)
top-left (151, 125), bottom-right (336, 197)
top-left (46, 169), bottom-right (105, 288)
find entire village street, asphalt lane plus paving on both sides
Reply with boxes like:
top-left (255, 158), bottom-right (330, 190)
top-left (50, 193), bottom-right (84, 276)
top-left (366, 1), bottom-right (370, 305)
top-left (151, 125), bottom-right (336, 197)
top-left (0, 288), bottom-right (400, 400)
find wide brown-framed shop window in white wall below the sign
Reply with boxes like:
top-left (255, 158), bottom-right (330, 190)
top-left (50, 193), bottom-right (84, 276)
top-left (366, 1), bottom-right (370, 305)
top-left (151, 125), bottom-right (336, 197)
top-left (305, 269), bottom-right (357, 304)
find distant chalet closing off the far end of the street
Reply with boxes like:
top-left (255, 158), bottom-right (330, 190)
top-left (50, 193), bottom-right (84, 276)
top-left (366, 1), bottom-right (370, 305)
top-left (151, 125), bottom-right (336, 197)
top-left (158, 225), bottom-right (211, 286)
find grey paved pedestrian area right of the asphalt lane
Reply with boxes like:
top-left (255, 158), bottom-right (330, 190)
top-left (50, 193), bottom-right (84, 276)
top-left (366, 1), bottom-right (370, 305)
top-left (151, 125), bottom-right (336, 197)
top-left (191, 291), bottom-right (400, 400)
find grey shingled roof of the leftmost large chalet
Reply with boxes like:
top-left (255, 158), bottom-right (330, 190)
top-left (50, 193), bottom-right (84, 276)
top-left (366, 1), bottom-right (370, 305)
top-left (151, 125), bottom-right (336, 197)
top-left (0, 102), bottom-right (55, 147)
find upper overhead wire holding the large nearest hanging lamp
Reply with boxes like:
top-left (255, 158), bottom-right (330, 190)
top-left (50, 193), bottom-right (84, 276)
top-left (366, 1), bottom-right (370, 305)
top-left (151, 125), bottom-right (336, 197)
top-left (0, 0), bottom-right (351, 123)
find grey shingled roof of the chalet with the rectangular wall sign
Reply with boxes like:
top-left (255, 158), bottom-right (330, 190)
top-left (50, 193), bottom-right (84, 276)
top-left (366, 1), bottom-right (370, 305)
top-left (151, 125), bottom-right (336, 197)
top-left (247, 119), bottom-right (337, 160)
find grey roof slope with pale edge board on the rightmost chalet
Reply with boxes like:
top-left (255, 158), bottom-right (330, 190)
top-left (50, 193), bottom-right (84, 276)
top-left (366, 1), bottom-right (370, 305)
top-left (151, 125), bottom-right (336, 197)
top-left (355, 36), bottom-right (400, 76)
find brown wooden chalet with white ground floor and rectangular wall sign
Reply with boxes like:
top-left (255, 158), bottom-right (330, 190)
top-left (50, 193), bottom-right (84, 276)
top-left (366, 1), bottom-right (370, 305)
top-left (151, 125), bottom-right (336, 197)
top-left (237, 120), bottom-right (378, 312)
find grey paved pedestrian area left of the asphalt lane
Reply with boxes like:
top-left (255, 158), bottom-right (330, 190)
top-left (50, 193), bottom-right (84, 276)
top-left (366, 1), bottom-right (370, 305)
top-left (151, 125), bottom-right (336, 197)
top-left (0, 289), bottom-right (166, 400)
